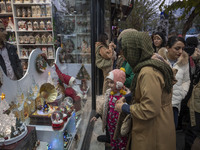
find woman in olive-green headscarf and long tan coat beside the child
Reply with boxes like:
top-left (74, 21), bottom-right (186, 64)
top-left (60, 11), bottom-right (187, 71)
top-left (115, 29), bottom-right (176, 150)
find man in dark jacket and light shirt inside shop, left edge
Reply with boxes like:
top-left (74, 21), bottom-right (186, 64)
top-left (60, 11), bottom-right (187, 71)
top-left (0, 20), bottom-right (23, 80)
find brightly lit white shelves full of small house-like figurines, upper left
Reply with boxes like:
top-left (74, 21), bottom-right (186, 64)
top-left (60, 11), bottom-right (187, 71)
top-left (12, 0), bottom-right (55, 68)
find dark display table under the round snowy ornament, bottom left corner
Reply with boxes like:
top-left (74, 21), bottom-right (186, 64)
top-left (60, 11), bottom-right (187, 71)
top-left (0, 126), bottom-right (37, 150)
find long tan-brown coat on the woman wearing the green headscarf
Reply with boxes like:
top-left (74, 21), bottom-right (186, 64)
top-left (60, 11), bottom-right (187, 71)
top-left (126, 67), bottom-right (176, 150)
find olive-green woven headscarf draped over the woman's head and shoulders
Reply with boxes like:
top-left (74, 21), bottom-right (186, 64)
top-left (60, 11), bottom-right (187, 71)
top-left (119, 29), bottom-right (173, 95)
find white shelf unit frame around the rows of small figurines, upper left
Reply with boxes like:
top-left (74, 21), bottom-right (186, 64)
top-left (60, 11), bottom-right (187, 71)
top-left (11, 0), bottom-right (55, 61)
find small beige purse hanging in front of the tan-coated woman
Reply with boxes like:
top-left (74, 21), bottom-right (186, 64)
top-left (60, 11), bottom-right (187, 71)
top-left (120, 114), bottom-right (132, 136)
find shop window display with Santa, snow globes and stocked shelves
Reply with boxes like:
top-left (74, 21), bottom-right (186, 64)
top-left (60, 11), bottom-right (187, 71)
top-left (0, 0), bottom-right (91, 150)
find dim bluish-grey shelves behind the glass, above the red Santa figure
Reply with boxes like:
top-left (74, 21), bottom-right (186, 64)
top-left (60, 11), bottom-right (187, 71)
top-left (57, 14), bottom-right (91, 64)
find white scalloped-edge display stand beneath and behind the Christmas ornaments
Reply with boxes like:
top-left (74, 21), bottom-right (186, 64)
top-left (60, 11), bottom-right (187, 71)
top-left (0, 48), bottom-right (91, 150)
